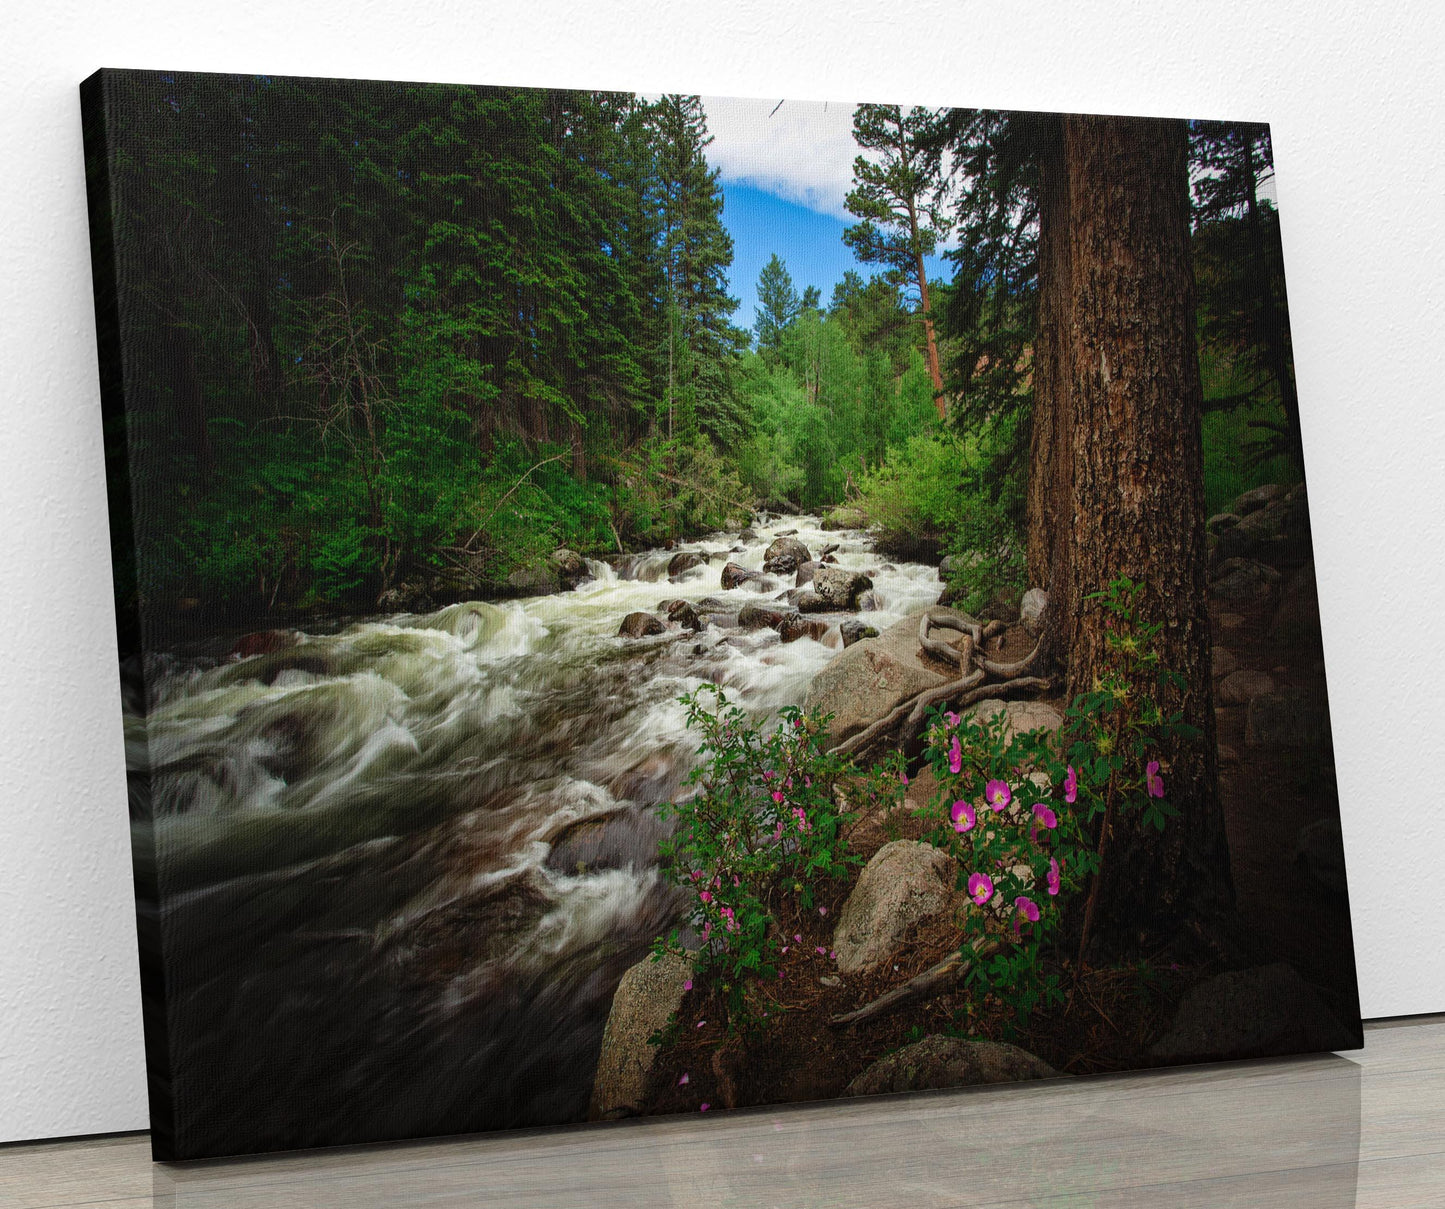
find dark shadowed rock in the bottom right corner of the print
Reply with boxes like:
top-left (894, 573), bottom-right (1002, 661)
top-left (1150, 962), bottom-right (1363, 1062)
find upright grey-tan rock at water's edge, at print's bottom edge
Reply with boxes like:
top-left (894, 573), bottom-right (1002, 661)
top-left (587, 953), bottom-right (692, 1121)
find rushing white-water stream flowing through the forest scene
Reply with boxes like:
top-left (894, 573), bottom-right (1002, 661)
top-left (127, 517), bottom-right (939, 1154)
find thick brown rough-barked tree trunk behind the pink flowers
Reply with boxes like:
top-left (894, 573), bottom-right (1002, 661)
top-left (1064, 117), bottom-right (1231, 953)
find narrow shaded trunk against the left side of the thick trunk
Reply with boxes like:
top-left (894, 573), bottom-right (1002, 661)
top-left (1026, 118), bottom-right (1074, 667)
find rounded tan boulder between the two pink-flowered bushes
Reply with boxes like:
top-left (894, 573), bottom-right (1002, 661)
top-left (832, 839), bottom-right (957, 974)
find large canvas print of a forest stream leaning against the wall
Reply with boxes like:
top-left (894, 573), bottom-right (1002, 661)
top-left (82, 71), bottom-right (1361, 1158)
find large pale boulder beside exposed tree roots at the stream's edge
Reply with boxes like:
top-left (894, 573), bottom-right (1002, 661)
top-left (803, 610), bottom-right (946, 747)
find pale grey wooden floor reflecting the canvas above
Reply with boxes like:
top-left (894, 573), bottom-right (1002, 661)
top-left (0, 1017), bottom-right (1445, 1209)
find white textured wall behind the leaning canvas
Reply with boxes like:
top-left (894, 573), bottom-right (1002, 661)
top-left (0, 0), bottom-right (1445, 1140)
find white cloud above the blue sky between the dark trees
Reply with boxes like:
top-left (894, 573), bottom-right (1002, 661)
top-left (702, 97), bottom-right (858, 221)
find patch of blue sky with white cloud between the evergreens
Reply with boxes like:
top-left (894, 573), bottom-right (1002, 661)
top-left (702, 97), bottom-right (951, 342)
